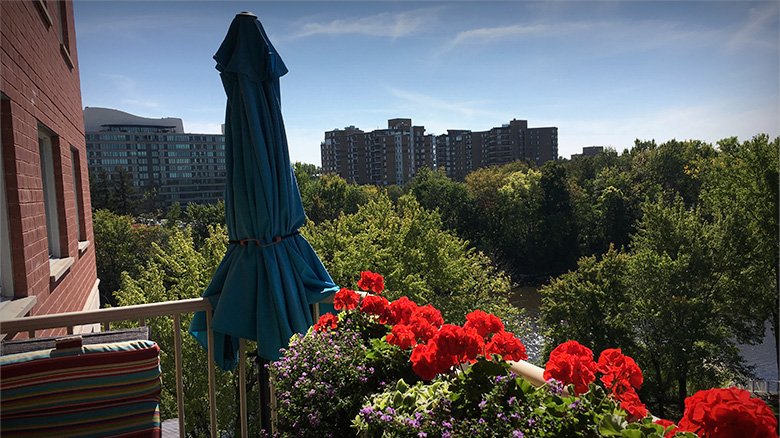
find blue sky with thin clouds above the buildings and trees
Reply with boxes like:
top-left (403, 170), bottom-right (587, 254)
top-left (74, 0), bottom-right (780, 165)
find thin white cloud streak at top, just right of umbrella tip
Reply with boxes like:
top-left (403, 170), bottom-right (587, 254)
top-left (294, 9), bottom-right (436, 38)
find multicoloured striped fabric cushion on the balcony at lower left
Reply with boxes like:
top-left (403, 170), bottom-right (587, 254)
top-left (0, 341), bottom-right (161, 437)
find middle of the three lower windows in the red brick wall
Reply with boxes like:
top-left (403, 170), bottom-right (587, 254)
top-left (38, 123), bottom-right (62, 258)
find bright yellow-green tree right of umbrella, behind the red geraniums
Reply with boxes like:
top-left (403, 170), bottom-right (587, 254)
top-left (301, 194), bottom-right (518, 327)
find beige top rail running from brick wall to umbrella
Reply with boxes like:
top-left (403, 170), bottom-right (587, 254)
top-left (0, 297), bottom-right (211, 333)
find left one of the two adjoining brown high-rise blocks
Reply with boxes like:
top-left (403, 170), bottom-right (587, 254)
top-left (320, 119), bottom-right (434, 186)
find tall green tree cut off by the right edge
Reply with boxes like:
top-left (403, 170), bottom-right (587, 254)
top-left (688, 135), bottom-right (780, 378)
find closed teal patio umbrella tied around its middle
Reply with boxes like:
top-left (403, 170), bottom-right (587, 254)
top-left (189, 13), bottom-right (338, 371)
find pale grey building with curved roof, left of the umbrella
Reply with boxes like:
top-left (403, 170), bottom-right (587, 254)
top-left (84, 107), bottom-right (226, 208)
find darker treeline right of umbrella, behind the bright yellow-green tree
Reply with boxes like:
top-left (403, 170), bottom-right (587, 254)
top-left (296, 135), bottom-right (780, 418)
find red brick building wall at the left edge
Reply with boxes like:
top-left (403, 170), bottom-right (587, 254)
top-left (0, 0), bottom-right (99, 335)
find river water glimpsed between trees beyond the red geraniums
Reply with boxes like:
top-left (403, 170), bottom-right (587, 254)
top-left (512, 286), bottom-right (778, 381)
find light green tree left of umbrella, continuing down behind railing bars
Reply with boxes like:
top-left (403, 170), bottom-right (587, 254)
top-left (115, 226), bottom-right (260, 436)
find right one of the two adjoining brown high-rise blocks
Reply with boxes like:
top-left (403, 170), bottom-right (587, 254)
top-left (436, 119), bottom-right (558, 181)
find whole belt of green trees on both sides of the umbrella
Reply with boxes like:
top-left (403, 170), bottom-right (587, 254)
top-left (93, 136), bottom-right (780, 428)
